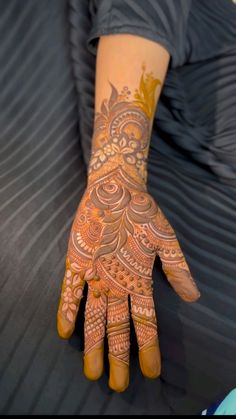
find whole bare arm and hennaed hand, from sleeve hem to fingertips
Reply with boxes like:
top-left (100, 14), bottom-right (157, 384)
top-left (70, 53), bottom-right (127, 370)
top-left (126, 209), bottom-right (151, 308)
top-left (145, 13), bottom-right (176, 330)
top-left (57, 35), bottom-right (200, 392)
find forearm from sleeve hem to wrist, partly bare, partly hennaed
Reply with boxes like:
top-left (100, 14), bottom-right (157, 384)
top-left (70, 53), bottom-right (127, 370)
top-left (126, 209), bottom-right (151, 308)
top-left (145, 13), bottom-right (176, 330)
top-left (88, 35), bottom-right (169, 184)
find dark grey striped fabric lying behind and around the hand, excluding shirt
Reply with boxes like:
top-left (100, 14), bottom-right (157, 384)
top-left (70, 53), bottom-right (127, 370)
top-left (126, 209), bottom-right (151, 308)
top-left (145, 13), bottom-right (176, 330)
top-left (0, 0), bottom-right (236, 415)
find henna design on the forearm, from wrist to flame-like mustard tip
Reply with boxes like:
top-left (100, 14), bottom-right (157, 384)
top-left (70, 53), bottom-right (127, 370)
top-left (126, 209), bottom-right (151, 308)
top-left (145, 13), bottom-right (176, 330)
top-left (88, 68), bottom-right (161, 183)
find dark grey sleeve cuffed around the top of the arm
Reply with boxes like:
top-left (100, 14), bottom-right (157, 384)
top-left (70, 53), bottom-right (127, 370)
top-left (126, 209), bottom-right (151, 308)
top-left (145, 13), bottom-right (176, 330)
top-left (88, 0), bottom-right (192, 68)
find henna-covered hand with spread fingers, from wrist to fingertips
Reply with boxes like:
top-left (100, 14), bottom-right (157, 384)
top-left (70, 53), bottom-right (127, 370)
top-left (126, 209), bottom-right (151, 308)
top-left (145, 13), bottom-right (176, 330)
top-left (58, 169), bottom-right (200, 391)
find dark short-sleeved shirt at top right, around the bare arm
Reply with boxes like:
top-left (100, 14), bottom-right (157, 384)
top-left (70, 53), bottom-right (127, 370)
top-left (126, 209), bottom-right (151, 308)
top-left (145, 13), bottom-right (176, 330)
top-left (88, 0), bottom-right (236, 185)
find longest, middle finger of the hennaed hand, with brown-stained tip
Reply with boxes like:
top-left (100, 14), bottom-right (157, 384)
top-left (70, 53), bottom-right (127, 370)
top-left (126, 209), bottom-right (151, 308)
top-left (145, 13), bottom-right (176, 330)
top-left (107, 296), bottom-right (130, 392)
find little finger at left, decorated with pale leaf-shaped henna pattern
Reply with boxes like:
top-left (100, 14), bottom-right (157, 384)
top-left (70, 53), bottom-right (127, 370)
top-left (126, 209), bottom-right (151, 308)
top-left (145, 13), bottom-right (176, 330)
top-left (57, 258), bottom-right (84, 339)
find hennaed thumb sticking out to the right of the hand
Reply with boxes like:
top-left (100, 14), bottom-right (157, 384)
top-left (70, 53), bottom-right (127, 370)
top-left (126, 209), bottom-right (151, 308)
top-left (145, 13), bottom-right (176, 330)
top-left (150, 209), bottom-right (200, 302)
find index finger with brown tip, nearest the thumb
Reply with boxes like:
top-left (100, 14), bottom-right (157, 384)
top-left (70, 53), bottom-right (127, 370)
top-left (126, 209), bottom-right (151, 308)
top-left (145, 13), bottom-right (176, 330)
top-left (131, 295), bottom-right (161, 378)
